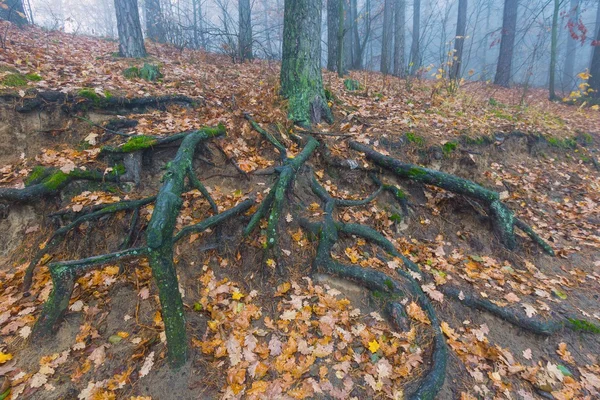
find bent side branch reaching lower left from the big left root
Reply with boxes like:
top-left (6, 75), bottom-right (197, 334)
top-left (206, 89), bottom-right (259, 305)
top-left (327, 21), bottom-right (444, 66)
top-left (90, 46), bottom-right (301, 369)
top-left (32, 248), bottom-right (146, 340)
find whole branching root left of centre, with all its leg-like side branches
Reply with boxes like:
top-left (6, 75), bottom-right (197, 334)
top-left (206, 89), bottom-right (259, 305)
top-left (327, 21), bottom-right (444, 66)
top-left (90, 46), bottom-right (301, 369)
top-left (34, 126), bottom-right (254, 367)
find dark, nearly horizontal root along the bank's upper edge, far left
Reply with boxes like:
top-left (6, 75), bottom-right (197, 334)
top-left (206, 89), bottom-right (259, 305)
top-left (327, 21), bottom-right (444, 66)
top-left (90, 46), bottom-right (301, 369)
top-left (8, 90), bottom-right (198, 113)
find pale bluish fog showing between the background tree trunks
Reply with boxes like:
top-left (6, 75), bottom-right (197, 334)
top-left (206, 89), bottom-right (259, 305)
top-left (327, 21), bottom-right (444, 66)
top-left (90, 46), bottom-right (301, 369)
top-left (25, 0), bottom-right (599, 93)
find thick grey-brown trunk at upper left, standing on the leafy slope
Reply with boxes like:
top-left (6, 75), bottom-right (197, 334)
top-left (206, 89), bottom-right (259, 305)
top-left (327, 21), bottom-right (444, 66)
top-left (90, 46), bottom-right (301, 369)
top-left (115, 0), bottom-right (146, 58)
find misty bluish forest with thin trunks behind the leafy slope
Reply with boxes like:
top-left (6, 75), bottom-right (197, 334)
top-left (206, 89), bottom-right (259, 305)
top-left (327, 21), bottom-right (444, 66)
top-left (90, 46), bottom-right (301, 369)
top-left (6, 0), bottom-right (600, 98)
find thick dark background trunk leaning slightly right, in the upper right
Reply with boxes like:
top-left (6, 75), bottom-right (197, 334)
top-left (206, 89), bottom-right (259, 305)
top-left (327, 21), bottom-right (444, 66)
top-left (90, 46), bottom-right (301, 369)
top-left (494, 0), bottom-right (519, 87)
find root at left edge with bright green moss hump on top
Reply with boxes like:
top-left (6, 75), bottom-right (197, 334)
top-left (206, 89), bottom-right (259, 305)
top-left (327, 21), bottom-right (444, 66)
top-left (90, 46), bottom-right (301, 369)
top-left (0, 168), bottom-right (118, 203)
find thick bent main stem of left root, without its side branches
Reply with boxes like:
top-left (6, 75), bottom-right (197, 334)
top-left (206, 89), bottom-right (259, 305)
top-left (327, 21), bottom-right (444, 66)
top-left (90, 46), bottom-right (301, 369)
top-left (146, 125), bottom-right (225, 367)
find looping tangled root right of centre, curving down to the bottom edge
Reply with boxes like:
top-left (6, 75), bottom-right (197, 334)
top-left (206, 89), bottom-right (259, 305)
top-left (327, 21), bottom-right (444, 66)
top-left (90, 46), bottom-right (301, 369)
top-left (300, 172), bottom-right (448, 400)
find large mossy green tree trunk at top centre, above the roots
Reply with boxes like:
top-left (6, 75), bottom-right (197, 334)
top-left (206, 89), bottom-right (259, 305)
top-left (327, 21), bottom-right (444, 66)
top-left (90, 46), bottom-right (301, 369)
top-left (281, 0), bottom-right (333, 127)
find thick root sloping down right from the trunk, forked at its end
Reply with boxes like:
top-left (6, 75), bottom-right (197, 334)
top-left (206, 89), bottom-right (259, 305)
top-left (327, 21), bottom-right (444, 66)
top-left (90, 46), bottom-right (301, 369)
top-left (350, 142), bottom-right (554, 256)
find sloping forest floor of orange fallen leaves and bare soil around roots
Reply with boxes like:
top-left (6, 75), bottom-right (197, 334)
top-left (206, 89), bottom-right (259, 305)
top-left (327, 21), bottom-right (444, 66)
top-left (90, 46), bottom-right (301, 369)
top-left (0, 24), bottom-right (600, 400)
